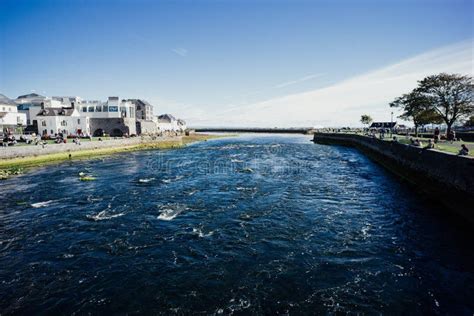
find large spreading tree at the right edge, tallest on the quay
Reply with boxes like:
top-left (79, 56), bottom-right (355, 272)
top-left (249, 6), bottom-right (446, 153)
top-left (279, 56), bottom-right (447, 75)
top-left (416, 73), bottom-right (474, 134)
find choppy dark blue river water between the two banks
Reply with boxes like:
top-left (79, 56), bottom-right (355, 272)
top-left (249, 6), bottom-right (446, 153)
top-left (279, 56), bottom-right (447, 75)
top-left (0, 136), bottom-right (474, 315)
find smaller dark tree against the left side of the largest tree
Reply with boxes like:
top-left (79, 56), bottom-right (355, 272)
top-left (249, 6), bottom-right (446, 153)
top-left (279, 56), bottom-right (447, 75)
top-left (390, 89), bottom-right (443, 137)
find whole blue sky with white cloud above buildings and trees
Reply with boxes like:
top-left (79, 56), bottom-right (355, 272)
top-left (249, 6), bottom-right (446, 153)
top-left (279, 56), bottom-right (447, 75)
top-left (0, 0), bottom-right (474, 127)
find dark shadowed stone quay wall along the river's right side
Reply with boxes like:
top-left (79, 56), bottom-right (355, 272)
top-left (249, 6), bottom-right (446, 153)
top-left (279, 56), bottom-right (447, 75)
top-left (313, 133), bottom-right (474, 224)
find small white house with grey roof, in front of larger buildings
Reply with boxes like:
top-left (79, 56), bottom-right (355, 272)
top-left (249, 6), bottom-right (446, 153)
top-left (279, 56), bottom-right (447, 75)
top-left (37, 108), bottom-right (90, 136)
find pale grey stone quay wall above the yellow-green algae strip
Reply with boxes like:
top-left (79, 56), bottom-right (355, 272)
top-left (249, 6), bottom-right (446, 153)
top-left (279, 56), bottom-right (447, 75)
top-left (0, 137), bottom-right (182, 159)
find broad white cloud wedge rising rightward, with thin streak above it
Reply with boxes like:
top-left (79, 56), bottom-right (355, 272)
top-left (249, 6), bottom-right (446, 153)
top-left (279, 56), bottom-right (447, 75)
top-left (187, 39), bottom-right (474, 127)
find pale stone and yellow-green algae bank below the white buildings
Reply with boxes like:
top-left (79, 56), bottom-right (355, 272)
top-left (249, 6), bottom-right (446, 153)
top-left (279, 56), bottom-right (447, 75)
top-left (0, 134), bottom-right (224, 179)
